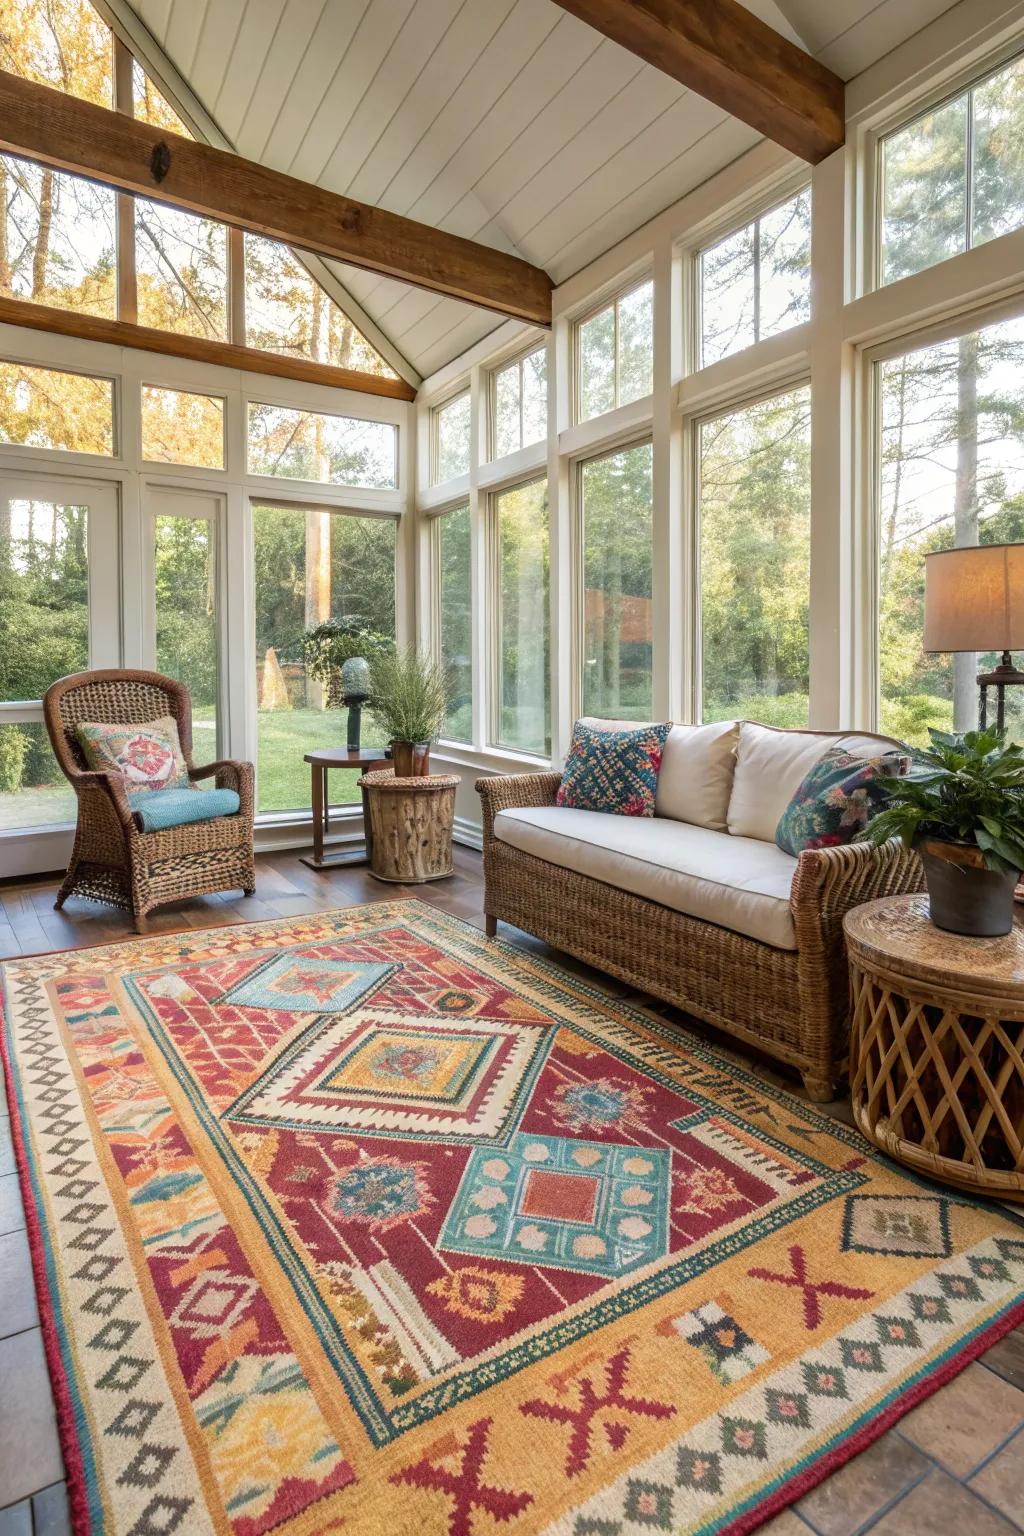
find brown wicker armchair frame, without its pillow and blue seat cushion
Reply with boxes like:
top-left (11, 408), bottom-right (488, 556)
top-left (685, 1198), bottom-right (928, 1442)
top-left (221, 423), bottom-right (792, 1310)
top-left (43, 671), bottom-right (256, 934)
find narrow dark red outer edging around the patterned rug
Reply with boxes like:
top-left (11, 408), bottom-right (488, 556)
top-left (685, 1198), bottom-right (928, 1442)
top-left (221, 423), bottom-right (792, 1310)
top-left (0, 897), bottom-right (1024, 1536)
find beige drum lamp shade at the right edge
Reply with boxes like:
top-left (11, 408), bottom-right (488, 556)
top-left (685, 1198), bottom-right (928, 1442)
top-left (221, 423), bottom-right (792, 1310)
top-left (924, 544), bottom-right (1024, 651)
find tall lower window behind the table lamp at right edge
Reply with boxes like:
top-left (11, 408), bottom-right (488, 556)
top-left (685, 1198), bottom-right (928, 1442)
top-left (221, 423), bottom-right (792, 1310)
top-left (878, 319), bottom-right (1024, 743)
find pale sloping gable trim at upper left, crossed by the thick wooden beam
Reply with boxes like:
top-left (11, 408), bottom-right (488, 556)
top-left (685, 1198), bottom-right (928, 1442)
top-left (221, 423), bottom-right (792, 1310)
top-left (92, 0), bottom-right (424, 389)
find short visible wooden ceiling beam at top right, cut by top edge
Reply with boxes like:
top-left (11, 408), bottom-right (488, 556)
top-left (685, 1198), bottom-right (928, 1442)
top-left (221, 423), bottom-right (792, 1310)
top-left (556, 0), bottom-right (846, 164)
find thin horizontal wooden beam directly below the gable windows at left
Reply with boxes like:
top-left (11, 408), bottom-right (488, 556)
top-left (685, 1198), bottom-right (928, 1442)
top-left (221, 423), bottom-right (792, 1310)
top-left (0, 298), bottom-right (416, 399)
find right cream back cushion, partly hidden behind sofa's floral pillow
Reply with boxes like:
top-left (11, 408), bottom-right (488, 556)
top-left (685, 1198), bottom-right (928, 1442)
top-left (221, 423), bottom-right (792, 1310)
top-left (728, 720), bottom-right (897, 842)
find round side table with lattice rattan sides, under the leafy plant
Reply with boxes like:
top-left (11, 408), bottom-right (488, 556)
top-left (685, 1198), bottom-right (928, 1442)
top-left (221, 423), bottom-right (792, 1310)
top-left (844, 895), bottom-right (1024, 1200)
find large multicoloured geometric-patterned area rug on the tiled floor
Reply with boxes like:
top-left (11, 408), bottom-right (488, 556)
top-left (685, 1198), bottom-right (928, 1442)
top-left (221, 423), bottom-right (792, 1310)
top-left (5, 902), bottom-right (1024, 1536)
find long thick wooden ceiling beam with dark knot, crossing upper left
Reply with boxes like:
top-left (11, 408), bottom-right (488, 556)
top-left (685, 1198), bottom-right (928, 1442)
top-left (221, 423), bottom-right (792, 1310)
top-left (0, 71), bottom-right (551, 326)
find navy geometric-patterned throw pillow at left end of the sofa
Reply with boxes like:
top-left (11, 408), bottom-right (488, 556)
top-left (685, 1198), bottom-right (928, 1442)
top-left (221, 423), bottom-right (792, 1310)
top-left (557, 720), bottom-right (672, 816)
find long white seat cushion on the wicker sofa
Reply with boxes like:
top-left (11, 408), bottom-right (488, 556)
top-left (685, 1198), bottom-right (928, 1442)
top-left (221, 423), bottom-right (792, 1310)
top-left (494, 806), bottom-right (797, 949)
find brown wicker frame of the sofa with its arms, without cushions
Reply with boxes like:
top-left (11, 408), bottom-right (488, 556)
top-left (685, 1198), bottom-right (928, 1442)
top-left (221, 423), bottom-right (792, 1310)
top-left (476, 773), bottom-right (923, 1103)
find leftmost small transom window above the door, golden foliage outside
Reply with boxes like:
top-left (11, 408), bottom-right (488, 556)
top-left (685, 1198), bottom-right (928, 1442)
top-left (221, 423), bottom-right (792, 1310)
top-left (0, 362), bottom-right (114, 456)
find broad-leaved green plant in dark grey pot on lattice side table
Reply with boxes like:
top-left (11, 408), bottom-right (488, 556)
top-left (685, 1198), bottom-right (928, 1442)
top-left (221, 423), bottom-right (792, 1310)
top-left (861, 730), bottom-right (1024, 935)
